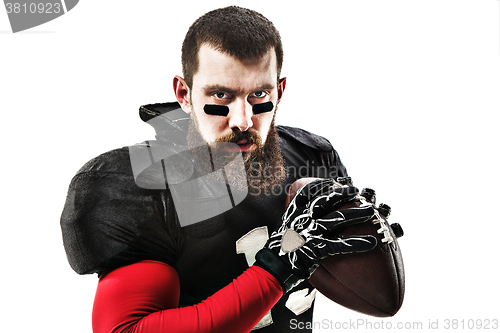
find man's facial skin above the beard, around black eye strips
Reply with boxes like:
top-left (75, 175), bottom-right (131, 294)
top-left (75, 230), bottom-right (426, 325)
top-left (181, 45), bottom-right (285, 152)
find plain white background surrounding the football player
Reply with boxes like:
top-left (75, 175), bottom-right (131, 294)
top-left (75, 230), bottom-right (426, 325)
top-left (0, 0), bottom-right (500, 333)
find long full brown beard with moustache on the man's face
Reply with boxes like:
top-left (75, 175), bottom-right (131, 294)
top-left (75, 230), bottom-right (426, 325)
top-left (187, 106), bottom-right (287, 196)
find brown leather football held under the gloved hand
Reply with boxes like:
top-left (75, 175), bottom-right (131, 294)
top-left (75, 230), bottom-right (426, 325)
top-left (287, 178), bottom-right (405, 317)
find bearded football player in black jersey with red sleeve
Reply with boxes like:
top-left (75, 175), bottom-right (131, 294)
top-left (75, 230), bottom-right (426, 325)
top-left (61, 6), bottom-right (376, 333)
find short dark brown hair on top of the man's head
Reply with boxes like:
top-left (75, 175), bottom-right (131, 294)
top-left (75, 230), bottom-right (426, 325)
top-left (182, 6), bottom-right (283, 89)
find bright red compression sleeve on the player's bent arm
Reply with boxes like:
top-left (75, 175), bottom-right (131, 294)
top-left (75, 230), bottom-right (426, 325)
top-left (92, 261), bottom-right (283, 333)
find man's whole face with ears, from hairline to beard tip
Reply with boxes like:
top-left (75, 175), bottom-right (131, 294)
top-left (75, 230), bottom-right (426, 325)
top-left (174, 45), bottom-right (286, 195)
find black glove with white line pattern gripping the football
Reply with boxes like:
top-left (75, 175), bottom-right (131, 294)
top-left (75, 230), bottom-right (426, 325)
top-left (256, 179), bottom-right (377, 293)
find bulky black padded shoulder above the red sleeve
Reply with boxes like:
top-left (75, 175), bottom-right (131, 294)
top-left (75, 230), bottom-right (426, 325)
top-left (61, 147), bottom-right (178, 274)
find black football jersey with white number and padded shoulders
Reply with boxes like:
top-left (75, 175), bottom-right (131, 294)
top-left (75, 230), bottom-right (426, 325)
top-left (61, 104), bottom-right (347, 332)
